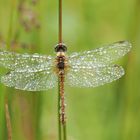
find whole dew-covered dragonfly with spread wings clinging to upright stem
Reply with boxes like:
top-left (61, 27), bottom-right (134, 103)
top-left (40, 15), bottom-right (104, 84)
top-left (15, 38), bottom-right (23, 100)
top-left (0, 41), bottom-right (132, 123)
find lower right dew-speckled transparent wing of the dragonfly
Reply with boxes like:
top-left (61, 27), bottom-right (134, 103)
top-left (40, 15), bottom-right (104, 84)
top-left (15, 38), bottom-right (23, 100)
top-left (66, 65), bottom-right (124, 87)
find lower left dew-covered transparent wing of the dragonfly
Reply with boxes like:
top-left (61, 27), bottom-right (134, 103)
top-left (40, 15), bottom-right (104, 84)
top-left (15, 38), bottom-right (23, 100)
top-left (1, 71), bottom-right (57, 91)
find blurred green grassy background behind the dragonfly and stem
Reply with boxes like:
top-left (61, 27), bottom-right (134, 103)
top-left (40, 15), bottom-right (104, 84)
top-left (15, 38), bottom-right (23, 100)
top-left (0, 0), bottom-right (140, 140)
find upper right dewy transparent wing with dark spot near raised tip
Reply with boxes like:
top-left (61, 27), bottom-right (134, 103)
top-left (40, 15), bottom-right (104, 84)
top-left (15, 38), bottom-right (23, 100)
top-left (68, 41), bottom-right (131, 67)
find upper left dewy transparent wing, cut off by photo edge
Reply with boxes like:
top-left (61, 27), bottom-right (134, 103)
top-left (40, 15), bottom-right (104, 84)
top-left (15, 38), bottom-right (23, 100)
top-left (0, 51), bottom-right (53, 72)
